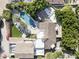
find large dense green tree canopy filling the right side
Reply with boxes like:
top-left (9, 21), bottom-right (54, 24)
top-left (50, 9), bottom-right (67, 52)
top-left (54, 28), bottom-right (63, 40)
top-left (56, 6), bottom-right (79, 50)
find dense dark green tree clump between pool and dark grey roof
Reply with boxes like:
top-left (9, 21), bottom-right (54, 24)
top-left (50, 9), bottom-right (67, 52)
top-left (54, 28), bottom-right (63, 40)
top-left (26, 0), bottom-right (49, 19)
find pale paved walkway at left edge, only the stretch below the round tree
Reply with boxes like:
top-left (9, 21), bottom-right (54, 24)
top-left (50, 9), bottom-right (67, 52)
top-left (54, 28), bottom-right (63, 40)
top-left (1, 19), bottom-right (9, 56)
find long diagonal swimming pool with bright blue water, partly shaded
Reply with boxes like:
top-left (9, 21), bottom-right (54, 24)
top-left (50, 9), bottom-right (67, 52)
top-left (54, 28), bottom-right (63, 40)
top-left (20, 12), bottom-right (37, 28)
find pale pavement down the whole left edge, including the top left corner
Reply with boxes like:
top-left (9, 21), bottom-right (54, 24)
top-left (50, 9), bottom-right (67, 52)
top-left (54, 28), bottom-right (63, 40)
top-left (0, 0), bottom-right (10, 59)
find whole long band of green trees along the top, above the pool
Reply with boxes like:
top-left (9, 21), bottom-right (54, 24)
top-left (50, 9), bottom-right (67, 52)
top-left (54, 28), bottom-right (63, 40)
top-left (6, 0), bottom-right (49, 19)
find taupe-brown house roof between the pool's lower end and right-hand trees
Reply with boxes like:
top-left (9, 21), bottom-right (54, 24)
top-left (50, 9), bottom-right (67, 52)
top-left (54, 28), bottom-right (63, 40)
top-left (39, 21), bottom-right (56, 49)
